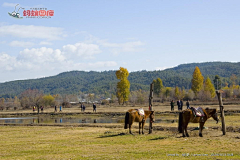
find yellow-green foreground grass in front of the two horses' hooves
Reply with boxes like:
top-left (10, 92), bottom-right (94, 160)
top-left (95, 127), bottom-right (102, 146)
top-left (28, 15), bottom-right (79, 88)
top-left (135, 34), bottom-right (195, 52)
top-left (0, 126), bottom-right (240, 159)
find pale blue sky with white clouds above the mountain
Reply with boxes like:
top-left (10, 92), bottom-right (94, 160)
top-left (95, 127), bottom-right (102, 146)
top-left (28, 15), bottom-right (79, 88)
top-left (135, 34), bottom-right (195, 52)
top-left (0, 0), bottom-right (240, 83)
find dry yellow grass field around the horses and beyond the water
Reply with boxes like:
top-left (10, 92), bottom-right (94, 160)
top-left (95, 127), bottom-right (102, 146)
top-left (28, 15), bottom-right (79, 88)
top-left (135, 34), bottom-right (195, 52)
top-left (0, 102), bottom-right (240, 160)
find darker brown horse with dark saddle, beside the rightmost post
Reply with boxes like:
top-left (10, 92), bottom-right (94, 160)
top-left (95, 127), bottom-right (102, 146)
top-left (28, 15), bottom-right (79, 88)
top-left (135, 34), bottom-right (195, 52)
top-left (182, 108), bottom-right (219, 137)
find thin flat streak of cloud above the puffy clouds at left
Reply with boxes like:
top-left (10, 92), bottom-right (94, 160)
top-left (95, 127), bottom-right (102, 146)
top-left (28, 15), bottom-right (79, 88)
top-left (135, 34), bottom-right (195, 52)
top-left (0, 25), bottom-right (66, 40)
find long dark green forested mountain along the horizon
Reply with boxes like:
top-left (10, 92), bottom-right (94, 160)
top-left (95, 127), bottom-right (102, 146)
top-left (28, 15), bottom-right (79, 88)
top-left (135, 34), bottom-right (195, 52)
top-left (0, 62), bottom-right (240, 98)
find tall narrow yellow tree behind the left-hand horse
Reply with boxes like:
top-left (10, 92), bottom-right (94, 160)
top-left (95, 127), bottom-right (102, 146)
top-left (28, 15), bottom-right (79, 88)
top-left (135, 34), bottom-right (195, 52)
top-left (116, 67), bottom-right (130, 104)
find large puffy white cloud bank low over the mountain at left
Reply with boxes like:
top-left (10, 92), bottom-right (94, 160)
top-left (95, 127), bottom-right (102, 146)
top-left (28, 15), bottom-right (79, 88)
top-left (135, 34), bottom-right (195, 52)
top-left (0, 41), bottom-right (111, 73)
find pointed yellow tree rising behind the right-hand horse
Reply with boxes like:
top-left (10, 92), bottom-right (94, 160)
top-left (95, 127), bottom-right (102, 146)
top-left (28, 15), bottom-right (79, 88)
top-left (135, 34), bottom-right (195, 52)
top-left (191, 66), bottom-right (204, 95)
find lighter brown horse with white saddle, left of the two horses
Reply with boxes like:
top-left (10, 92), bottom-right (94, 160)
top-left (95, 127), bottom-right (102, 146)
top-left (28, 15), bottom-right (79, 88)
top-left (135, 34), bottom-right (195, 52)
top-left (124, 109), bottom-right (155, 134)
